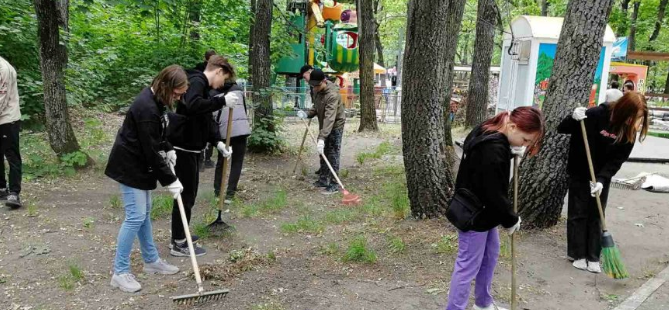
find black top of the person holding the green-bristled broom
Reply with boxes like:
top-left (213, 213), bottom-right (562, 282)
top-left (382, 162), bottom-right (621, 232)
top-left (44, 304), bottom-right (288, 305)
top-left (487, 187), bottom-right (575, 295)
top-left (558, 103), bottom-right (634, 184)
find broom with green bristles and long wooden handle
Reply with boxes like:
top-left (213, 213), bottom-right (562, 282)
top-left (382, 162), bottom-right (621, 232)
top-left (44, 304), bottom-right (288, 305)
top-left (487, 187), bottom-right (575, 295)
top-left (581, 120), bottom-right (629, 279)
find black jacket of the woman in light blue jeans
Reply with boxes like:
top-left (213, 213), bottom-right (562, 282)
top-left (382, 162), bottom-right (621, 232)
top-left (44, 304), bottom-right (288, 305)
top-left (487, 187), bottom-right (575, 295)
top-left (105, 87), bottom-right (177, 190)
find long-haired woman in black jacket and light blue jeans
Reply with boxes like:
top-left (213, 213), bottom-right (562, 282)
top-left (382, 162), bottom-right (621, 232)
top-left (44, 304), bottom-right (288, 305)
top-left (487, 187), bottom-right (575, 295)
top-left (105, 65), bottom-right (188, 292)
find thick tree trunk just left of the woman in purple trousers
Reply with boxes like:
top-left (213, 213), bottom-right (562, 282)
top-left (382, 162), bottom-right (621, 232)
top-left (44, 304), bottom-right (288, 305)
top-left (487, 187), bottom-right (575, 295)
top-left (402, 0), bottom-right (456, 218)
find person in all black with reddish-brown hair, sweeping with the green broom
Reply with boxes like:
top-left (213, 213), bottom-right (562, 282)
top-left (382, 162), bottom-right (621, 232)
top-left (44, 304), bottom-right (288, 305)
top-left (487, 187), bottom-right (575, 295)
top-left (558, 92), bottom-right (649, 273)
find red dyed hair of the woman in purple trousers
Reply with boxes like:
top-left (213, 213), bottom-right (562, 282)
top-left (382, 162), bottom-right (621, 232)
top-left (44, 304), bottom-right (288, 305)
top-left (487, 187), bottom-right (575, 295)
top-left (482, 107), bottom-right (546, 156)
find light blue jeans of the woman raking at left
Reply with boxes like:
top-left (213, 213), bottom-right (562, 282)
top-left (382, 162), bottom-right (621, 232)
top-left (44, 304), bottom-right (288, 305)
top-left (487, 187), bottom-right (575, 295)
top-left (114, 184), bottom-right (158, 274)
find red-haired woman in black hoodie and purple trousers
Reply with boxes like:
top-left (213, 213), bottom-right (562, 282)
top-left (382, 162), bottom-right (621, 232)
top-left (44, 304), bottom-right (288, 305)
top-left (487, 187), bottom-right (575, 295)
top-left (446, 107), bottom-right (544, 310)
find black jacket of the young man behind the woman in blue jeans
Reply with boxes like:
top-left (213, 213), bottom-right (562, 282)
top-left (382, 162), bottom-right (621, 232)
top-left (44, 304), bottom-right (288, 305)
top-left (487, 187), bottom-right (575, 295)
top-left (168, 70), bottom-right (225, 151)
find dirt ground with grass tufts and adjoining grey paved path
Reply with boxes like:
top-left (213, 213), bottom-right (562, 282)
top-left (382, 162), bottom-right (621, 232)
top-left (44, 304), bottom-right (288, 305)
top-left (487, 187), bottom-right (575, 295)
top-left (0, 118), bottom-right (669, 310)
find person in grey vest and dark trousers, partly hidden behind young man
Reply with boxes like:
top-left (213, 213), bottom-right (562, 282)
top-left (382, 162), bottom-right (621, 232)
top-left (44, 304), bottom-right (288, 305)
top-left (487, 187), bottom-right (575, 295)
top-left (210, 82), bottom-right (251, 204)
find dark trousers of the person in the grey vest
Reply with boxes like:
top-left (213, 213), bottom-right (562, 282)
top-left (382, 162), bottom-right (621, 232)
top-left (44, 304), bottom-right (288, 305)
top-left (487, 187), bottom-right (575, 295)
top-left (214, 136), bottom-right (247, 199)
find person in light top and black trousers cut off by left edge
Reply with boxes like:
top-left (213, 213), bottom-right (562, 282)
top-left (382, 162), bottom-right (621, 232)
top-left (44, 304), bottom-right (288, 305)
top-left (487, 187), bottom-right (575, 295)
top-left (0, 57), bottom-right (23, 209)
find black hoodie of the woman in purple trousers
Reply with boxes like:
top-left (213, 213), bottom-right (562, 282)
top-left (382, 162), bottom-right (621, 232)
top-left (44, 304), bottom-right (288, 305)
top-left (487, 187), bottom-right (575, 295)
top-left (455, 125), bottom-right (518, 231)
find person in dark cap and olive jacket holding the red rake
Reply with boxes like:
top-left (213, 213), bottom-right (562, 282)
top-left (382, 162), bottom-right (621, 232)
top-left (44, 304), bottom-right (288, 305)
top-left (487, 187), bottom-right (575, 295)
top-left (297, 69), bottom-right (346, 195)
